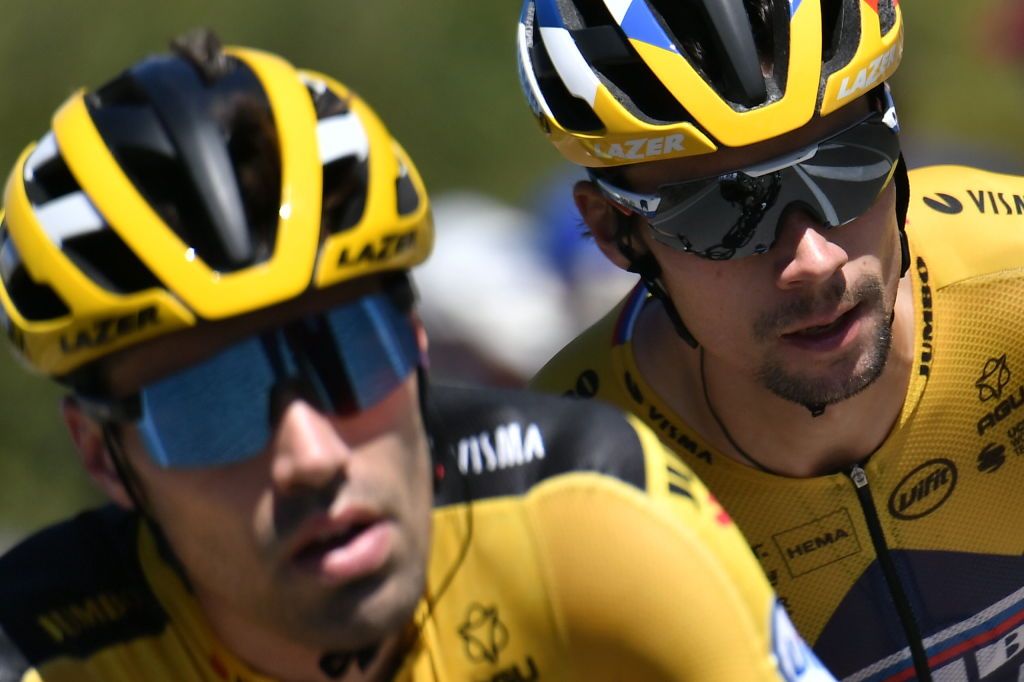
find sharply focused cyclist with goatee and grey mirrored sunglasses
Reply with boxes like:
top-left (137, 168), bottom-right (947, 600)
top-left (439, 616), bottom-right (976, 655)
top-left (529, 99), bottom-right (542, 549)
top-left (518, 0), bottom-right (1024, 680)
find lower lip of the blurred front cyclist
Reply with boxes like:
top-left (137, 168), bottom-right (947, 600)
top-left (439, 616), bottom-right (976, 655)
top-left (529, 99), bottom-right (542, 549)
top-left (293, 521), bottom-right (394, 584)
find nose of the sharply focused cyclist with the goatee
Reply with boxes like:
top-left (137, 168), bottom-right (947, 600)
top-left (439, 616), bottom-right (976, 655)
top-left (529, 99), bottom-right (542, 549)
top-left (769, 210), bottom-right (850, 290)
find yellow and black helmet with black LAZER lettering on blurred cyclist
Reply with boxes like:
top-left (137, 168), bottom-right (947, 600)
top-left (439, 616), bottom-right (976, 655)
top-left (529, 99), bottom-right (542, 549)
top-left (0, 33), bottom-right (433, 384)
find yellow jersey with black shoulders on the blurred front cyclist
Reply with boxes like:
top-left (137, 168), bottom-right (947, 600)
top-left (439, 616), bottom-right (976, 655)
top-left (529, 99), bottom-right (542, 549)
top-left (0, 389), bottom-right (834, 682)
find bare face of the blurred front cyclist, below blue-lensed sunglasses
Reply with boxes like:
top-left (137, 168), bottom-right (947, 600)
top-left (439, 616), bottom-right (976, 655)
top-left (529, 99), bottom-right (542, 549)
top-left (98, 282), bottom-right (432, 650)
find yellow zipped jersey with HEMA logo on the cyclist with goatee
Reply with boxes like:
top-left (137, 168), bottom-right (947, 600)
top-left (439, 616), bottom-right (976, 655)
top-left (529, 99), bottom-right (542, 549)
top-left (534, 166), bottom-right (1024, 682)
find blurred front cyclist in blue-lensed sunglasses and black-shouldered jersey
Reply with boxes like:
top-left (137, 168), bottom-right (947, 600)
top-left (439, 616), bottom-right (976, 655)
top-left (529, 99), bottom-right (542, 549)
top-left (0, 33), bottom-right (833, 682)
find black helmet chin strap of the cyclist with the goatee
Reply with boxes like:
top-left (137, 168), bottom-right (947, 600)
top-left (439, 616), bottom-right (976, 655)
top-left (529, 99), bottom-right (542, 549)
top-left (615, 154), bottom-right (910, 417)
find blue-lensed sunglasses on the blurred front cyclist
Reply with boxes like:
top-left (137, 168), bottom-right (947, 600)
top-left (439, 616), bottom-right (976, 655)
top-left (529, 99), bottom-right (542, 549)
top-left (78, 292), bottom-right (420, 469)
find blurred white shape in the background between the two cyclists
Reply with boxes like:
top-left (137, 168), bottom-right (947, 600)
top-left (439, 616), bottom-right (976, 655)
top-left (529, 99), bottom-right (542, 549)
top-left (414, 193), bottom-right (578, 386)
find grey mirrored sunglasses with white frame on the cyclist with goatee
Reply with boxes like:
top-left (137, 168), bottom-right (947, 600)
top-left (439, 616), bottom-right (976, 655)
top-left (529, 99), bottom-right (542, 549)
top-left (591, 85), bottom-right (900, 260)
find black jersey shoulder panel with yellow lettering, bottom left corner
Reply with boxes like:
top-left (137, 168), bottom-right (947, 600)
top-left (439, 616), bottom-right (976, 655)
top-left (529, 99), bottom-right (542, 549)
top-left (0, 507), bottom-right (161, 667)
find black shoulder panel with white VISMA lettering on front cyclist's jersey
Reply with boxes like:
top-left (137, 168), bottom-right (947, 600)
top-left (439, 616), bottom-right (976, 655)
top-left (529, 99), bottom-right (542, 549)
top-left (430, 387), bottom-right (659, 505)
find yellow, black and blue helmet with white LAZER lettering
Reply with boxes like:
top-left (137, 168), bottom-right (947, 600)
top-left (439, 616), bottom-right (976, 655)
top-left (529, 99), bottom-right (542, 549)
top-left (517, 0), bottom-right (903, 167)
